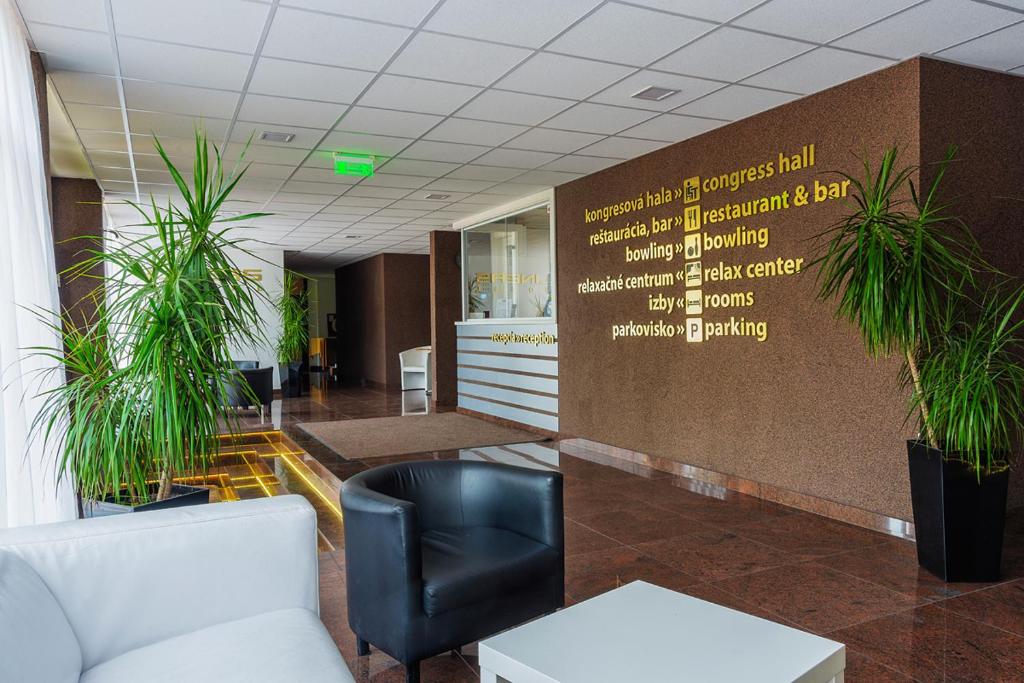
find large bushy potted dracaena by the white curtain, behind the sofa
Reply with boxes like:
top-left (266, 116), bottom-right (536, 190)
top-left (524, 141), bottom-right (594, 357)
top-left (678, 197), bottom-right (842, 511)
top-left (32, 131), bottom-right (265, 515)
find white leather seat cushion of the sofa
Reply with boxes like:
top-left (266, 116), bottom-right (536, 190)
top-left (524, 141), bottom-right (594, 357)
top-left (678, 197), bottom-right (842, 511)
top-left (81, 610), bottom-right (353, 683)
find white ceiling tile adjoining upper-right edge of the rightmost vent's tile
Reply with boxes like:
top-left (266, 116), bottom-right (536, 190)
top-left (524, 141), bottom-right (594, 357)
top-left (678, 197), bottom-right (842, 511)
top-left (654, 27), bottom-right (811, 81)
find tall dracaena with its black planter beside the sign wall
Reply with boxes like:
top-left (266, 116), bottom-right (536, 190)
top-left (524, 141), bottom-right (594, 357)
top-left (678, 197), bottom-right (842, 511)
top-left (815, 147), bottom-right (1024, 582)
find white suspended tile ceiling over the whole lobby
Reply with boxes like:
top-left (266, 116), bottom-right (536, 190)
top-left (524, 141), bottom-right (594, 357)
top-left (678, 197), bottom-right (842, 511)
top-left (17, 0), bottom-right (1024, 270)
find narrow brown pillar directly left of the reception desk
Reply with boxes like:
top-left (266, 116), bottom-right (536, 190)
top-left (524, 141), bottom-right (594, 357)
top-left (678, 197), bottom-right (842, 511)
top-left (430, 230), bottom-right (462, 407)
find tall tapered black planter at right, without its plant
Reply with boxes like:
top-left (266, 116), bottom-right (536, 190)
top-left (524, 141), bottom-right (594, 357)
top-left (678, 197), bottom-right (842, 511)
top-left (906, 440), bottom-right (1010, 582)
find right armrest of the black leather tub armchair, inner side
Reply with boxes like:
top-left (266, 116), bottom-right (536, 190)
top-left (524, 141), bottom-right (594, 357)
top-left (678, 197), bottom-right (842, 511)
top-left (462, 462), bottom-right (565, 551)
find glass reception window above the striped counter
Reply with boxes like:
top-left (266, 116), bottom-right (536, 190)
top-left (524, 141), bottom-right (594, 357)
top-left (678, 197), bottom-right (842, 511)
top-left (462, 203), bottom-right (555, 321)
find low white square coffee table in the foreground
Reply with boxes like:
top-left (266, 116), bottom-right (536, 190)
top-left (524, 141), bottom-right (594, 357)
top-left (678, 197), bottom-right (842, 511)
top-left (479, 581), bottom-right (846, 683)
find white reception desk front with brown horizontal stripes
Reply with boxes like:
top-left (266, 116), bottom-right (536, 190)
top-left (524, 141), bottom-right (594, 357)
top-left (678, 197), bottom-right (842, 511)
top-left (456, 322), bottom-right (558, 432)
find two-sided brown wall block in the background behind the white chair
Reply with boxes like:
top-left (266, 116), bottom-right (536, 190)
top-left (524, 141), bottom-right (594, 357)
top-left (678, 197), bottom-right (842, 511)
top-left (335, 254), bottom-right (430, 388)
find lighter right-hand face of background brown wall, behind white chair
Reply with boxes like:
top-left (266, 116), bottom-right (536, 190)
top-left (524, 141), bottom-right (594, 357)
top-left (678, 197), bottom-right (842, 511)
top-left (383, 254), bottom-right (430, 388)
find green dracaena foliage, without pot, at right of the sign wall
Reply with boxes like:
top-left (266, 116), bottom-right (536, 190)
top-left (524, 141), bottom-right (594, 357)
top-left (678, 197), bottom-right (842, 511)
top-left (814, 146), bottom-right (1024, 477)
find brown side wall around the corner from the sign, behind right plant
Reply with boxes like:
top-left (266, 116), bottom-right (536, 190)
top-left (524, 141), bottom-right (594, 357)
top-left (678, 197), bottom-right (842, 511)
top-left (921, 59), bottom-right (1024, 505)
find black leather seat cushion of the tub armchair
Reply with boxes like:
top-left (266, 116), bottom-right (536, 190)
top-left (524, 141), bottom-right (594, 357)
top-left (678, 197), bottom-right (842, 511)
top-left (420, 526), bottom-right (559, 616)
